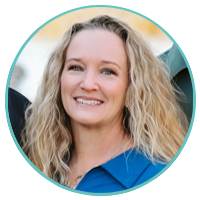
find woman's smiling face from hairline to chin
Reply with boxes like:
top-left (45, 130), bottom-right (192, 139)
top-left (61, 29), bottom-right (128, 126)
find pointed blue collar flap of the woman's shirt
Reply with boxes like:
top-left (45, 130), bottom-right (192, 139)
top-left (100, 149), bottom-right (151, 188)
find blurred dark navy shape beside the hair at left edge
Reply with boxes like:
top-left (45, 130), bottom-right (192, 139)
top-left (8, 88), bottom-right (30, 144)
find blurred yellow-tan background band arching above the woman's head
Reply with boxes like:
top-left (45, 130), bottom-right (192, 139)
top-left (36, 8), bottom-right (166, 38)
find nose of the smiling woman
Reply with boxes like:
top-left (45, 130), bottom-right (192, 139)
top-left (80, 71), bottom-right (99, 91)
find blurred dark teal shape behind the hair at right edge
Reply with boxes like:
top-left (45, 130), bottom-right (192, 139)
top-left (159, 45), bottom-right (193, 122)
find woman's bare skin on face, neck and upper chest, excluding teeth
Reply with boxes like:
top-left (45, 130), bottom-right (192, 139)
top-left (61, 29), bottom-right (133, 188)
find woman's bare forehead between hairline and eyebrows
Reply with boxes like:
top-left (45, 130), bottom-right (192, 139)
top-left (66, 29), bottom-right (127, 62)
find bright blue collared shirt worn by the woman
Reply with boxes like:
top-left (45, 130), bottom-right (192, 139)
top-left (75, 149), bottom-right (166, 193)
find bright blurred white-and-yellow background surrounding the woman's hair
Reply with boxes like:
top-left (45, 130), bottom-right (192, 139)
top-left (10, 8), bottom-right (173, 101)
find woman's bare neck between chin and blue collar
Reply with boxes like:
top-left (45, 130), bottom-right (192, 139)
top-left (69, 118), bottom-right (133, 174)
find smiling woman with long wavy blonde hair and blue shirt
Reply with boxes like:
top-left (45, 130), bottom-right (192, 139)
top-left (22, 16), bottom-right (188, 192)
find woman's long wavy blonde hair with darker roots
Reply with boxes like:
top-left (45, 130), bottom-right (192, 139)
top-left (22, 15), bottom-right (189, 185)
